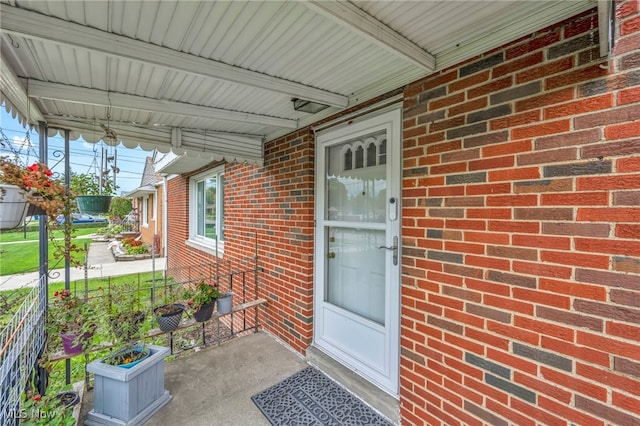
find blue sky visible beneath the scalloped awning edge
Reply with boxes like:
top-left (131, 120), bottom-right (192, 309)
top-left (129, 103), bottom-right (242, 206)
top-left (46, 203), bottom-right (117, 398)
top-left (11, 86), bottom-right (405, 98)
top-left (0, 104), bottom-right (152, 194)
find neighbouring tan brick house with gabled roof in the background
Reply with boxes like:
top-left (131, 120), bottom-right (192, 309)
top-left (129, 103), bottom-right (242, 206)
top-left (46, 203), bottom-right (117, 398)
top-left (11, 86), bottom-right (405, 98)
top-left (126, 153), bottom-right (165, 256)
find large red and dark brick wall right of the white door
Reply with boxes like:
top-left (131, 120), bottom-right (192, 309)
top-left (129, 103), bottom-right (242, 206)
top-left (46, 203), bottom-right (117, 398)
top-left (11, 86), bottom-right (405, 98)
top-left (401, 1), bottom-right (640, 425)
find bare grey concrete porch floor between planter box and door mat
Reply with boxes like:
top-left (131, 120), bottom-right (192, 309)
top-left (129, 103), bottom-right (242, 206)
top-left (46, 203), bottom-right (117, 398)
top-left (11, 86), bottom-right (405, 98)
top-left (79, 332), bottom-right (308, 426)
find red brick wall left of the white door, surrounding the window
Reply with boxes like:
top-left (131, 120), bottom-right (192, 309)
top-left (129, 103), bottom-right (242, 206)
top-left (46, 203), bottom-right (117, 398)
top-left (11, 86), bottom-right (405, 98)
top-left (168, 129), bottom-right (314, 353)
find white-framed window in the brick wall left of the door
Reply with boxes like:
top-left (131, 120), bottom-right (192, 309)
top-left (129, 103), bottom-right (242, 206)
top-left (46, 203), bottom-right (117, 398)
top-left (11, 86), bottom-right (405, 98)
top-left (189, 167), bottom-right (224, 249)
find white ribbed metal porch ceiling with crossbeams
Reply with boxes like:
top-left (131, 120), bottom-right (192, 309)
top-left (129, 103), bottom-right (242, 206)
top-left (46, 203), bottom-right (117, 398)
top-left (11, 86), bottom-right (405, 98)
top-left (0, 0), bottom-right (596, 162)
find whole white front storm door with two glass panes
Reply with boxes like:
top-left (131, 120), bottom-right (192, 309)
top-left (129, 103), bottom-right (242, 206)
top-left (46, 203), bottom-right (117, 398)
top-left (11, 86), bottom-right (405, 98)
top-left (314, 108), bottom-right (402, 396)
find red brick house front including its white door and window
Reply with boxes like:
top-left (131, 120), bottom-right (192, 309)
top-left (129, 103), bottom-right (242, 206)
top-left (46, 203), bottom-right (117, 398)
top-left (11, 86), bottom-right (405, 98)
top-left (164, 6), bottom-right (640, 425)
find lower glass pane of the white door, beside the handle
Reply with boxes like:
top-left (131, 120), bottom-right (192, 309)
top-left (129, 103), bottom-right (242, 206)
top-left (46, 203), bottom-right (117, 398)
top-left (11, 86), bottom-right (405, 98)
top-left (325, 227), bottom-right (386, 325)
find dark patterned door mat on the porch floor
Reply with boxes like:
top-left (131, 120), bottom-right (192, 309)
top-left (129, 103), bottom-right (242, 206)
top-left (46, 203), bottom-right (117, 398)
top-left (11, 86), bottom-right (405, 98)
top-left (251, 367), bottom-right (392, 426)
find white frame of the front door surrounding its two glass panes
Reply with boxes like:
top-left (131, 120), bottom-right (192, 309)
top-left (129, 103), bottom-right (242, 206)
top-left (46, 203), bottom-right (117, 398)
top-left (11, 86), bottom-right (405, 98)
top-left (313, 105), bottom-right (402, 397)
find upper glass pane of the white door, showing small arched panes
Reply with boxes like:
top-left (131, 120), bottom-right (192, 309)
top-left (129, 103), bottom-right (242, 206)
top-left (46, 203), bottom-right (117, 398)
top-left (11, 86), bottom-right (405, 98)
top-left (325, 131), bottom-right (387, 223)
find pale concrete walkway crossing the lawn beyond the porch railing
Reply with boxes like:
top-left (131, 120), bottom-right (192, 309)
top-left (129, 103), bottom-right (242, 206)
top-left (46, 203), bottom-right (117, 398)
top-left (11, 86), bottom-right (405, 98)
top-left (0, 241), bottom-right (166, 291)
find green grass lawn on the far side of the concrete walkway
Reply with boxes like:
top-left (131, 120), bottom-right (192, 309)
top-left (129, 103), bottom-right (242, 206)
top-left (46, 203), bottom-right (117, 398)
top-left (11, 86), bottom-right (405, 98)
top-left (0, 227), bottom-right (104, 276)
